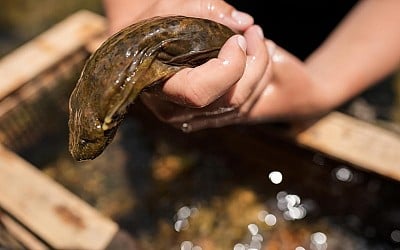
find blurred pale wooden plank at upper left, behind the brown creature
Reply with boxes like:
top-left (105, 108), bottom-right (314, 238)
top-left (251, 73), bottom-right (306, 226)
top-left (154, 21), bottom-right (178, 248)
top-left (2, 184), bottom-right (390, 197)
top-left (0, 10), bottom-right (106, 100)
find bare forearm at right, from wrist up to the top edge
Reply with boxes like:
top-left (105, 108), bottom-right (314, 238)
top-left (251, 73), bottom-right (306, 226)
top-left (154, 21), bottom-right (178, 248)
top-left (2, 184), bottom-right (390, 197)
top-left (306, 0), bottom-right (400, 107)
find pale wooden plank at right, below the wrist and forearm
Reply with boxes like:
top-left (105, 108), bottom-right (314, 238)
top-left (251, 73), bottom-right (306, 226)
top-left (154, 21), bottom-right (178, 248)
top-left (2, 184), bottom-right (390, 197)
top-left (295, 112), bottom-right (400, 181)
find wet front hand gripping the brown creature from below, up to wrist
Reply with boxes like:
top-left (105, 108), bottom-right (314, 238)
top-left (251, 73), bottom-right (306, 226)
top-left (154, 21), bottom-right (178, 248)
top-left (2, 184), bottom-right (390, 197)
top-left (141, 34), bottom-right (333, 132)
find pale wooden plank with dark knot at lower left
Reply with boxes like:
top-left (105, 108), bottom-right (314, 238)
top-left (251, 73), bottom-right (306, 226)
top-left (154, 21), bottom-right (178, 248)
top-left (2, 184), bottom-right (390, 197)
top-left (0, 146), bottom-right (118, 250)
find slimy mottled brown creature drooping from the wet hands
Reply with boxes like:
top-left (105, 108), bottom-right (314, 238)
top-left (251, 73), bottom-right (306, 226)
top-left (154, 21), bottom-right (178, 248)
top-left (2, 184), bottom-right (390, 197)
top-left (68, 16), bottom-right (234, 161)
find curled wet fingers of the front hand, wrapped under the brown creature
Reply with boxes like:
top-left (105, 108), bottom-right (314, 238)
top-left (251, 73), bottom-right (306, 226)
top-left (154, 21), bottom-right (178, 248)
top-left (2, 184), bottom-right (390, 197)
top-left (141, 25), bottom-right (271, 131)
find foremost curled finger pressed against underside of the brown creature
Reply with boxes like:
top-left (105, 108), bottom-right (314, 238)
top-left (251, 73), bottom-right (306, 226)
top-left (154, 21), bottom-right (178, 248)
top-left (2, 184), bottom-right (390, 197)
top-left (163, 35), bottom-right (247, 107)
